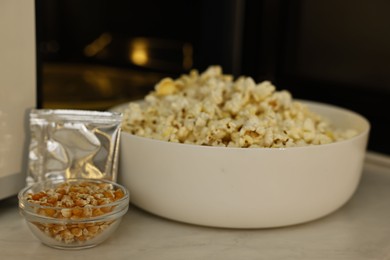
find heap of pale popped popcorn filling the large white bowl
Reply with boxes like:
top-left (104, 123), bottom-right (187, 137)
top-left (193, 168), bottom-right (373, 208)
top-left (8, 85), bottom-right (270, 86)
top-left (122, 66), bottom-right (357, 148)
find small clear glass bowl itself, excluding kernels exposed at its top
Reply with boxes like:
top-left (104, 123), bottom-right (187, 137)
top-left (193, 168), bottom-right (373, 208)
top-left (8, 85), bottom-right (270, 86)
top-left (18, 179), bottom-right (129, 249)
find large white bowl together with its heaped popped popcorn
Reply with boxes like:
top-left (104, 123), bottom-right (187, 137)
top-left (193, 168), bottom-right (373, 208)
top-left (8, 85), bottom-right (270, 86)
top-left (114, 66), bottom-right (370, 228)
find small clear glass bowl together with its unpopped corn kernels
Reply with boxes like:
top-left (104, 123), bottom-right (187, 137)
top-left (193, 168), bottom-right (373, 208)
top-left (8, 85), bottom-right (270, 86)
top-left (18, 179), bottom-right (129, 249)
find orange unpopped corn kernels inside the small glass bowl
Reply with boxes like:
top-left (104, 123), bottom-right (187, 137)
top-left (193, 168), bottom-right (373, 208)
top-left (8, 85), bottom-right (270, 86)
top-left (26, 181), bottom-right (124, 244)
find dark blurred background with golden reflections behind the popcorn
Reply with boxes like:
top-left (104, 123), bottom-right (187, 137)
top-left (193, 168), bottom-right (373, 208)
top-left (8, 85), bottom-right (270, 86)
top-left (36, 0), bottom-right (390, 154)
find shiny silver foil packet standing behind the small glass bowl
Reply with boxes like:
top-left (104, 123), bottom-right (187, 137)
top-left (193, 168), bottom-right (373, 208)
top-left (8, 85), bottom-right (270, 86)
top-left (26, 109), bottom-right (122, 185)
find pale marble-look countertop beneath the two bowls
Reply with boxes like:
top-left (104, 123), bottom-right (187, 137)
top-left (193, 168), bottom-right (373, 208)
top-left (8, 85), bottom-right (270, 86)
top-left (0, 153), bottom-right (390, 260)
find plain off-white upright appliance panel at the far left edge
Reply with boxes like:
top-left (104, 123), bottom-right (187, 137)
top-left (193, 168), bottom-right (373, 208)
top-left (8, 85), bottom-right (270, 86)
top-left (0, 0), bottom-right (37, 199)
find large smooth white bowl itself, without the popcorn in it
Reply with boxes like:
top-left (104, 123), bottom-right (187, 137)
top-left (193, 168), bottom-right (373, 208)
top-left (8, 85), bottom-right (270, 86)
top-left (119, 101), bottom-right (370, 228)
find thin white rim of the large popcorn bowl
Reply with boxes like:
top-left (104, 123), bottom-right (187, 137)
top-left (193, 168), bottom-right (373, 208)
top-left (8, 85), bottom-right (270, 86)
top-left (117, 99), bottom-right (371, 151)
